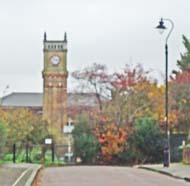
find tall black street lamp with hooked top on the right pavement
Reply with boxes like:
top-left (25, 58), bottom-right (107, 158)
top-left (156, 18), bottom-right (174, 167)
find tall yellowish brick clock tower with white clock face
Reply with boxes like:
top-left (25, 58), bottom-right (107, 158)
top-left (42, 33), bottom-right (68, 132)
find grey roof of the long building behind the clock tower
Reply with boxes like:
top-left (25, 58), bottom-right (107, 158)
top-left (0, 92), bottom-right (98, 107)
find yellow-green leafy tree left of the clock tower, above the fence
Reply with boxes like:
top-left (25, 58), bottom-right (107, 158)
top-left (1, 108), bottom-right (49, 145)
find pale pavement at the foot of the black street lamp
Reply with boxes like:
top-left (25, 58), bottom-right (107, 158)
top-left (138, 163), bottom-right (190, 181)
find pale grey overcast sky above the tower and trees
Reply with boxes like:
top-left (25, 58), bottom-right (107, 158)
top-left (0, 0), bottom-right (190, 95)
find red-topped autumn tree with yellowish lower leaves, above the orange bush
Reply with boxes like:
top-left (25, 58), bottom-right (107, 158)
top-left (105, 64), bottom-right (159, 125)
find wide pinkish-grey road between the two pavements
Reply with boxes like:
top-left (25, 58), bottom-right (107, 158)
top-left (40, 166), bottom-right (190, 186)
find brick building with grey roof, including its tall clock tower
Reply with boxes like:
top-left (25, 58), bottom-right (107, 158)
top-left (1, 33), bottom-right (98, 131)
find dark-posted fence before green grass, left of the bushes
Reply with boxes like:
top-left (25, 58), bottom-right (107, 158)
top-left (3, 143), bottom-right (73, 163)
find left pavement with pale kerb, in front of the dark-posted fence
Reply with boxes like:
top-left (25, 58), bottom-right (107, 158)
top-left (0, 163), bottom-right (41, 186)
